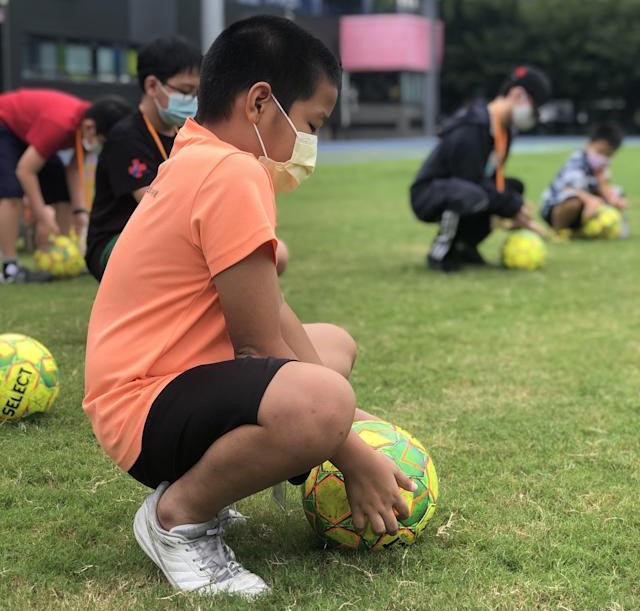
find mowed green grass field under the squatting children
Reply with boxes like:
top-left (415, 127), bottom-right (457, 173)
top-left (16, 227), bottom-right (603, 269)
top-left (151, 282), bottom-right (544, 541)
top-left (0, 148), bottom-right (640, 611)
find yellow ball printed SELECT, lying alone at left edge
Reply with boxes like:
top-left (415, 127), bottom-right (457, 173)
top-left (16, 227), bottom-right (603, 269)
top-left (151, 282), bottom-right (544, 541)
top-left (0, 333), bottom-right (60, 420)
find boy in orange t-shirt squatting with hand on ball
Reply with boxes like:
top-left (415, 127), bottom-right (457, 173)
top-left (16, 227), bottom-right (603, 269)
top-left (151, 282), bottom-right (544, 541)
top-left (83, 16), bottom-right (413, 596)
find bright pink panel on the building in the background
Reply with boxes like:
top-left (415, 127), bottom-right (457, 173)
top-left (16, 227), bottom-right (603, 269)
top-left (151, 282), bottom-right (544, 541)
top-left (340, 14), bottom-right (444, 72)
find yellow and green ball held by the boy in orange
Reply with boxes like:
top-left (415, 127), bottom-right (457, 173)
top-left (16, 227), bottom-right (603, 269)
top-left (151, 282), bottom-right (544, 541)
top-left (302, 420), bottom-right (438, 551)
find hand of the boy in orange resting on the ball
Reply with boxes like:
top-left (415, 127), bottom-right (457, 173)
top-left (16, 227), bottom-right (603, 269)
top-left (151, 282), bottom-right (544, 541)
top-left (342, 446), bottom-right (415, 535)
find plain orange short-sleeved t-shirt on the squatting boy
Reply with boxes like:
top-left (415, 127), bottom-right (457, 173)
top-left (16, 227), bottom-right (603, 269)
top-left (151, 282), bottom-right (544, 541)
top-left (83, 119), bottom-right (276, 471)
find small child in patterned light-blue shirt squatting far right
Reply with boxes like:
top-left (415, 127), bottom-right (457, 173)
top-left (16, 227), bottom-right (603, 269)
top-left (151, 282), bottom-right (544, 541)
top-left (540, 123), bottom-right (628, 230)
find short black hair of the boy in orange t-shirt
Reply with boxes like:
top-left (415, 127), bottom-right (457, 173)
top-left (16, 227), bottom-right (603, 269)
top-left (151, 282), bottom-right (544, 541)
top-left (196, 15), bottom-right (342, 123)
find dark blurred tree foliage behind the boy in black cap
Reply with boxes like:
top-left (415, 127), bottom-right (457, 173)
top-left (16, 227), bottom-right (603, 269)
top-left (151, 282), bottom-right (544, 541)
top-left (441, 0), bottom-right (640, 129)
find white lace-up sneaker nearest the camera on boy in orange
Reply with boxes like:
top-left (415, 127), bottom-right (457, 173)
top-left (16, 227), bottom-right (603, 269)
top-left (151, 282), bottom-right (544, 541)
top-left (133, 482), bottom-right (269, 597)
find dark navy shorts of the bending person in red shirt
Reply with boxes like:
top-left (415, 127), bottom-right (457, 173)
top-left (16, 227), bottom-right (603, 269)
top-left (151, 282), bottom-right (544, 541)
top-left (0, 124), bottom-right (70, 204)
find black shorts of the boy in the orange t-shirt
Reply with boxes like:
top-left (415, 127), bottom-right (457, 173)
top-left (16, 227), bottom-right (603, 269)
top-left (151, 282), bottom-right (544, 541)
top-left (129, 358), bottom-right (290, 488)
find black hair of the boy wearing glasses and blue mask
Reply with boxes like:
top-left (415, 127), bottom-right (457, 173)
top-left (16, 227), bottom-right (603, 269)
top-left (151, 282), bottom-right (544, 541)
top-left (138, 35), bottom-right (202, 91)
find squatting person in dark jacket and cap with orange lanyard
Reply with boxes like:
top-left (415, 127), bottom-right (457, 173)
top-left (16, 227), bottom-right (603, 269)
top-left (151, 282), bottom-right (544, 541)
top-left (410, 66), bottom-right (551, 273)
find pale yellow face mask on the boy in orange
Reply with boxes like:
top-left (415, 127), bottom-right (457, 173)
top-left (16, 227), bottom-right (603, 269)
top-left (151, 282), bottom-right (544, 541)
top-left (253, 93), bottom-right (318, 193)
